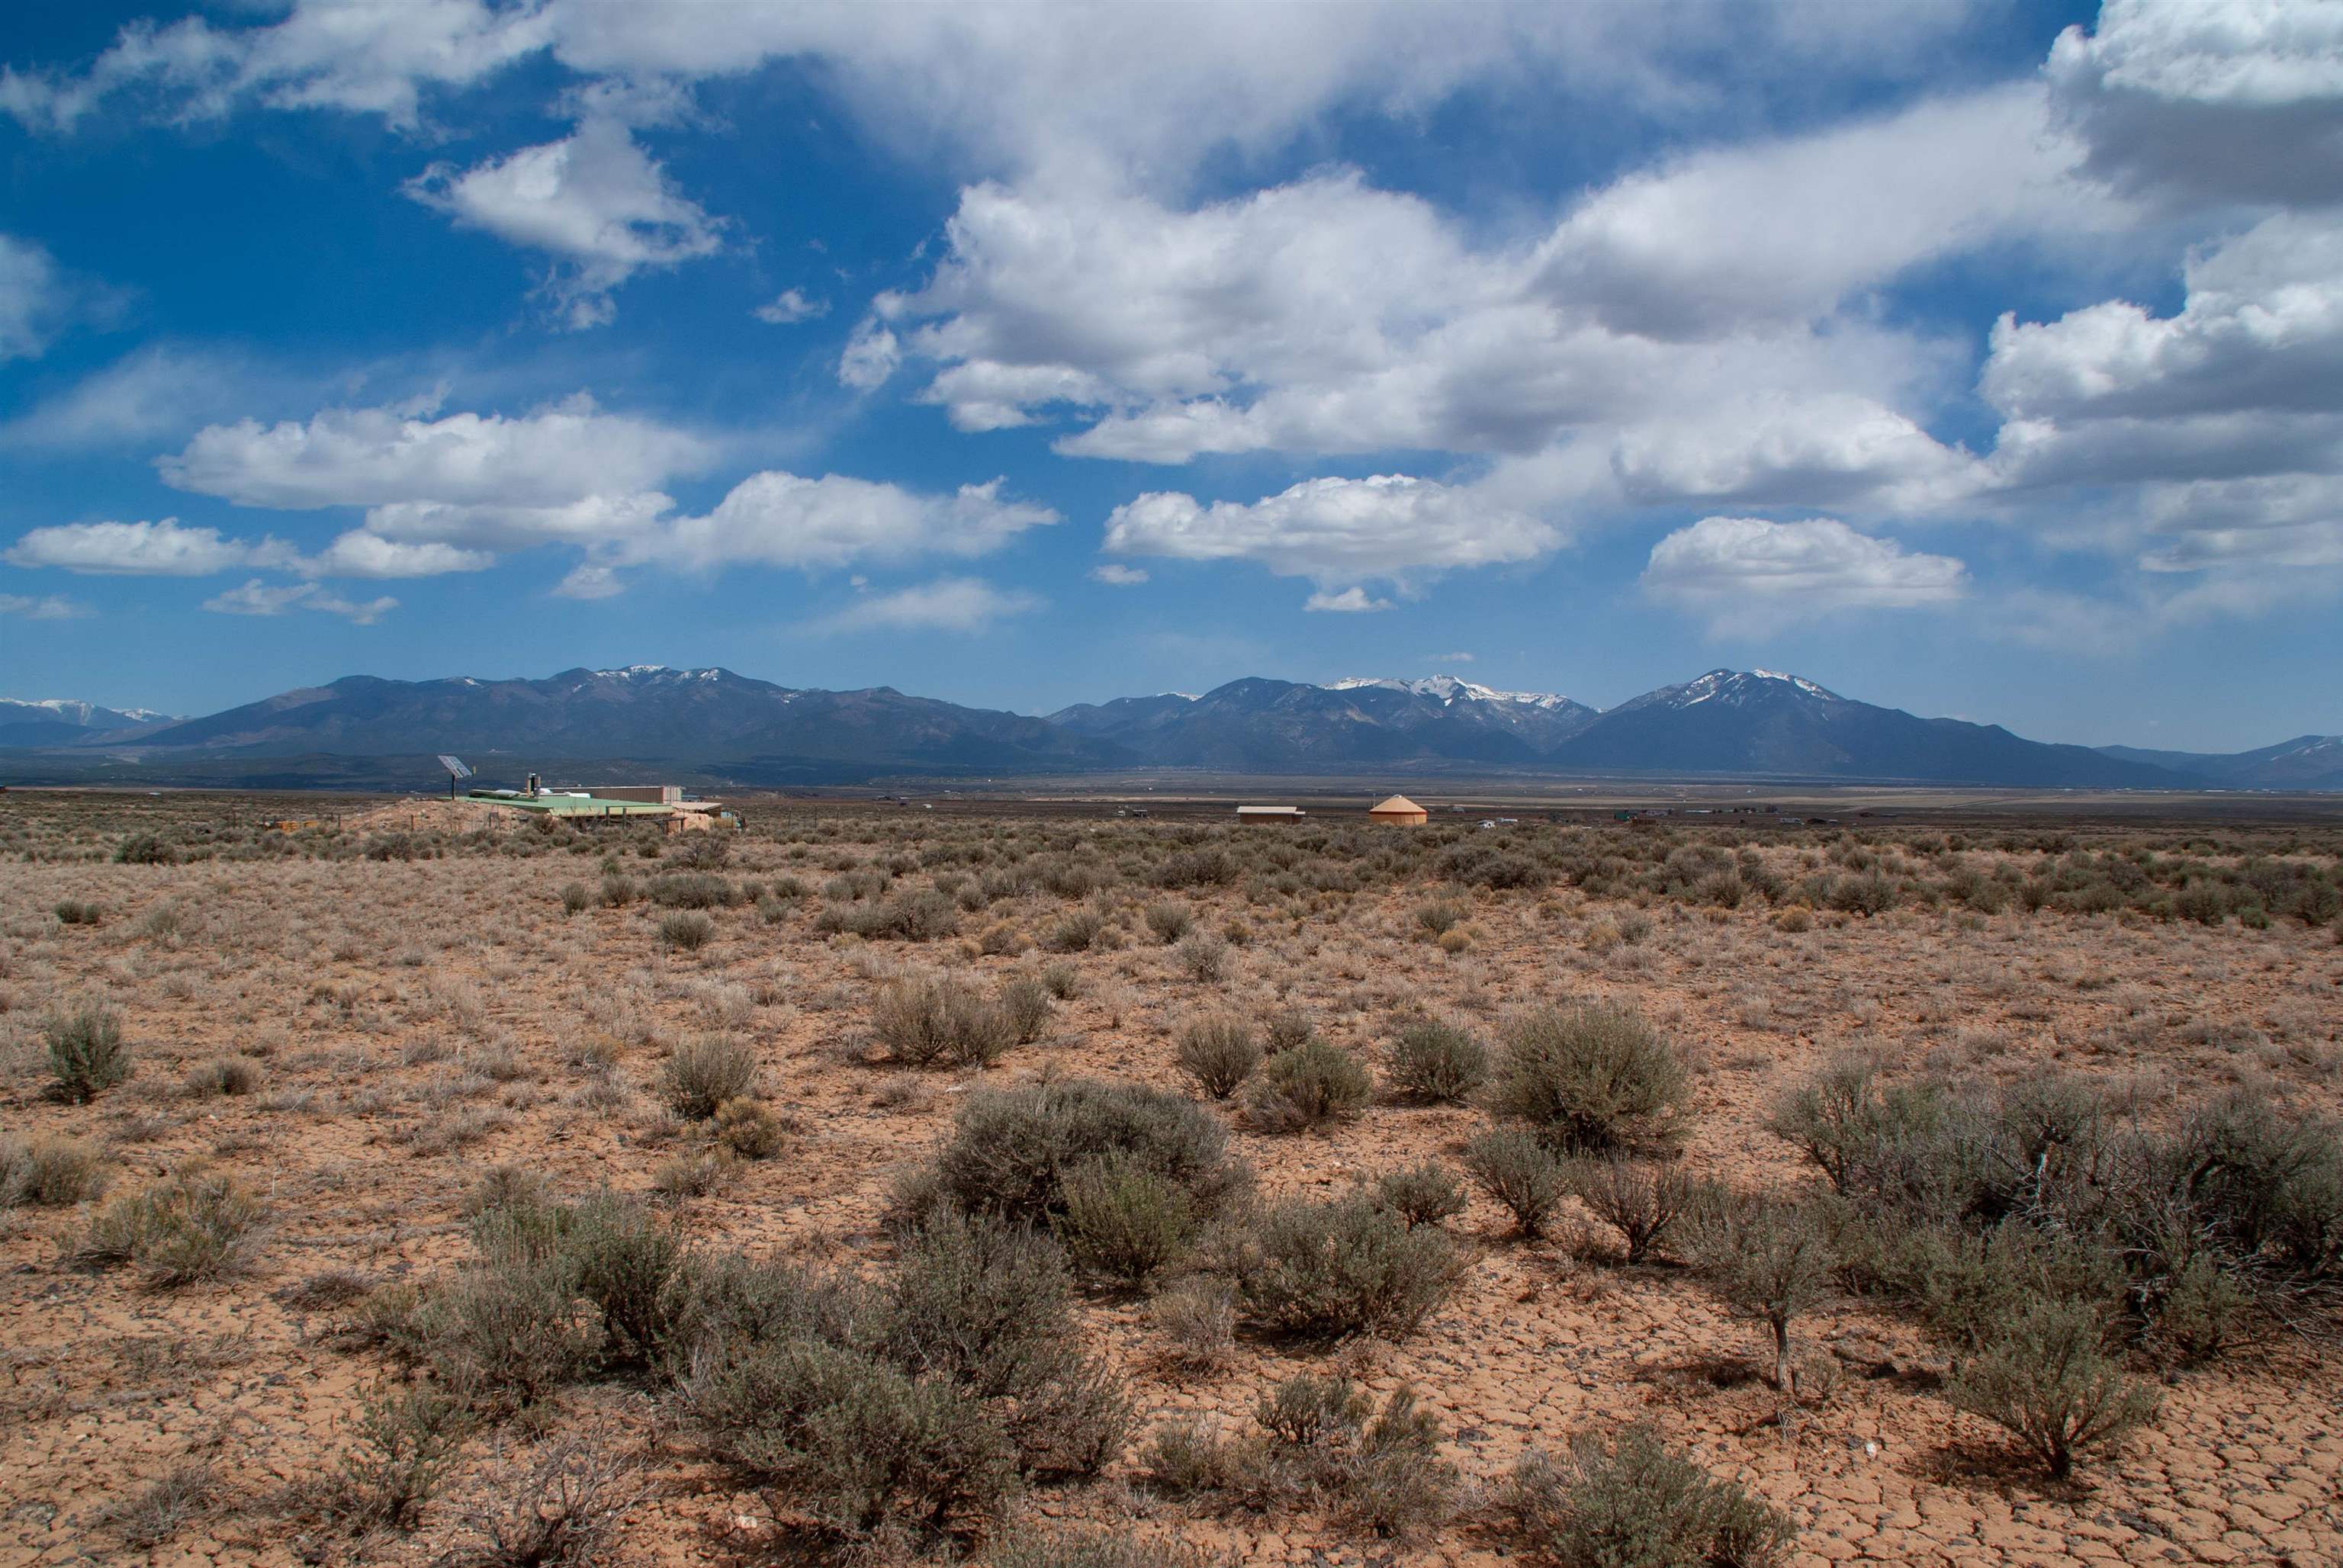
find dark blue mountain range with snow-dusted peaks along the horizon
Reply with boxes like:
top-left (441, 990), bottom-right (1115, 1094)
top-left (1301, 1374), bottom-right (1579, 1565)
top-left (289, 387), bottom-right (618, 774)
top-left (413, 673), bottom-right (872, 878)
top-left (0, 666), bottom-right (2343, 790)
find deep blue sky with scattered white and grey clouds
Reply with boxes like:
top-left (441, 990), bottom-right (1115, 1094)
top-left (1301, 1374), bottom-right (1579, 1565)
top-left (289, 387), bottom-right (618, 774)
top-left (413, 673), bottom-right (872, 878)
top-left (0, 0), bottom-right (2343, 750)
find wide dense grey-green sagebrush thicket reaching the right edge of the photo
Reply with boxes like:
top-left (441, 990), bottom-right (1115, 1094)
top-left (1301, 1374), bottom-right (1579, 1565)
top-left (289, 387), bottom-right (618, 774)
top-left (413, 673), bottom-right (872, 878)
top-left (1774, 1059), bottom-right (2343, 1362)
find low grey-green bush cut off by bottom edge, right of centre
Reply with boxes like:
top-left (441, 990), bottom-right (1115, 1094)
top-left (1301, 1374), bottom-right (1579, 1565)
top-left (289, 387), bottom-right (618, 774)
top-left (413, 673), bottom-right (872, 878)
top-left (1504, 1425), bottom-right (1795, 1568)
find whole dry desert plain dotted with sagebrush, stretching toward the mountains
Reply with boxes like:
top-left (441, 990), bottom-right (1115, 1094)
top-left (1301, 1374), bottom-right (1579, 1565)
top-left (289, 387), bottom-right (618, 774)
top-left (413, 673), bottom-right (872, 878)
top-left (0, 792), bottom-right (2343, 1568)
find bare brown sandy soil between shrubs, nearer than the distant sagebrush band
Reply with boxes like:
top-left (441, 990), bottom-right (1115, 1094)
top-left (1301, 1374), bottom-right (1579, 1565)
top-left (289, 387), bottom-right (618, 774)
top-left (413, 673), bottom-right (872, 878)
top-left (0, 804), bottom-right (2343, 1568)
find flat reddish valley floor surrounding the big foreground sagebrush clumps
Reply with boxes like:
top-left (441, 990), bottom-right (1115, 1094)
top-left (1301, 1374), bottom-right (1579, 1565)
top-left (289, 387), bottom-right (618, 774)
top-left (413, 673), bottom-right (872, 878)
top-left (0, 795), bottom-right (2343, 1568)
